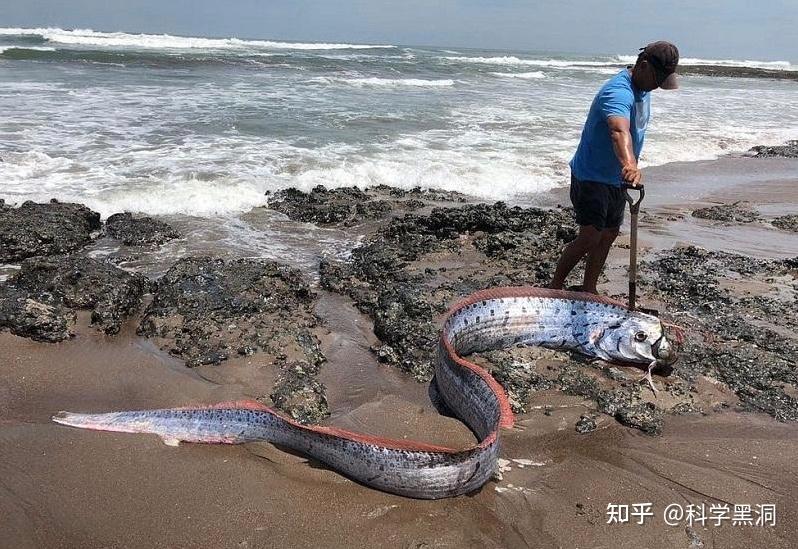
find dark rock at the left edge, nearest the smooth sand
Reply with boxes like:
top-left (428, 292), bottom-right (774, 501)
top-left (0, 255), bottom-right (147, 341)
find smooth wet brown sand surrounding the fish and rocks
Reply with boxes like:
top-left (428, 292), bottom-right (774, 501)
top-left (0, 153), bottom-right (798, 547)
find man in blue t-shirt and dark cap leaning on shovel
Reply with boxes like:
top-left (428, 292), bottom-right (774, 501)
top-left (551, 42), bottom-right (679, 293)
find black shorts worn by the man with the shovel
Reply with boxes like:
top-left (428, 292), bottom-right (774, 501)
top-left (571, 174), bottom-right (626, 231)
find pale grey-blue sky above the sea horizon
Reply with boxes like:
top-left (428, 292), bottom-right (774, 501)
top-left (0, 0), bottom-right (798, 62)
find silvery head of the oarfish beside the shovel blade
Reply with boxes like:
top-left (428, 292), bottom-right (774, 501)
top-left (596, 312), bottom-right (679, 366)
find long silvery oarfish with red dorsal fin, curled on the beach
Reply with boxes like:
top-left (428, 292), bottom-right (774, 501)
top-left (53, 287), bottom-right (676, 499)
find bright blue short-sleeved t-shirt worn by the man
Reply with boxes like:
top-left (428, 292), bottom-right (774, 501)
top-left (571, 69), bottom-right (651, 186)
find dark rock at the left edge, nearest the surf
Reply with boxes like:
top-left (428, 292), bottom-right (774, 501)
top-left (0, 201), bottom-right (100, 262)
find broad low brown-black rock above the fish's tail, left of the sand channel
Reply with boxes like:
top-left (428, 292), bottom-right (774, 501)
top-left (139, 257), bottom-right (323, 366)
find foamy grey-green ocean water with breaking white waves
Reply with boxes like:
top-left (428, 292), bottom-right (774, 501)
top-left (0, 28), bottom-right (798, 217)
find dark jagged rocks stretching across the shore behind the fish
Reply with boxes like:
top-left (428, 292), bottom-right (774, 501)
top-left (0, 149), bottom-right (798, 434)
